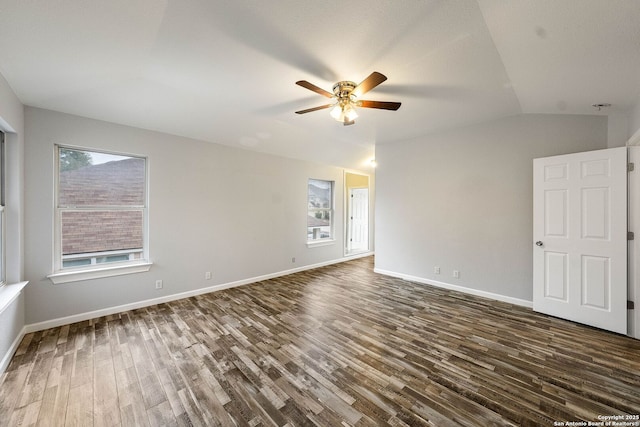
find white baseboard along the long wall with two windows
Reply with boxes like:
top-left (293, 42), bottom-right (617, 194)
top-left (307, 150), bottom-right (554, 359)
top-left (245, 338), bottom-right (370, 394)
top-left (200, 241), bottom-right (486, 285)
top-left (26, 252), bottom-right (373, 336)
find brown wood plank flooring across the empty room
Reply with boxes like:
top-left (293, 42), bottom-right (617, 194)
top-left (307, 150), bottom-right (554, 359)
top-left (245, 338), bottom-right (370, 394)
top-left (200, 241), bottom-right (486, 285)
top-left (0, 258), bottom-right (640, 426)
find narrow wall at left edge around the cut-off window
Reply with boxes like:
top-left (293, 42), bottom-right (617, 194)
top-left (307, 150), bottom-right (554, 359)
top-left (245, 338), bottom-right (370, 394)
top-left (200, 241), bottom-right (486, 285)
top-left (0, 75), bottom-right (25, 372)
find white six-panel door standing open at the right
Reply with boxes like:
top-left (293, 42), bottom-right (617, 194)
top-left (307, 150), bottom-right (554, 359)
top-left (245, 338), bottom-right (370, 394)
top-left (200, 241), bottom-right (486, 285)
top-left (533, 147), bottom-right (627, 334)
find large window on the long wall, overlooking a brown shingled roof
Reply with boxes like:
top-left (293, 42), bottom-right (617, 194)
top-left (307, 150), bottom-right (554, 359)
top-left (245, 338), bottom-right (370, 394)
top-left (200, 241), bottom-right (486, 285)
top-left (52, 146), bottom-right (148, 276)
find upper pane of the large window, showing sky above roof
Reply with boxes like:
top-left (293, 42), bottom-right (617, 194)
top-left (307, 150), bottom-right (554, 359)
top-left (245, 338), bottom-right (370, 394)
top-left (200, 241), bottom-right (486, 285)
top-left (58, 148), bottom-right (145, 207)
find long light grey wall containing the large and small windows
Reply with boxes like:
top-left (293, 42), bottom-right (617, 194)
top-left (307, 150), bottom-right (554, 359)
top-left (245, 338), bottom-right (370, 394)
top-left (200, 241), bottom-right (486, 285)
top-left (25, 108), bottom-right (368, 324)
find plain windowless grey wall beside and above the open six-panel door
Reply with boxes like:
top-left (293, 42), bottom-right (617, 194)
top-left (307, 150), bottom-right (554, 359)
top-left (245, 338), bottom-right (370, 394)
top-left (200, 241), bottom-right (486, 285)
top-left (375, 115), bottom-right (607, 302)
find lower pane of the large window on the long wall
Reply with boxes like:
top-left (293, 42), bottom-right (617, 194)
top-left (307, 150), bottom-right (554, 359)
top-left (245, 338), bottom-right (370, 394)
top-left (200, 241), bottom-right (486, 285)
top-left (61, 210), bottom-right (143, 256)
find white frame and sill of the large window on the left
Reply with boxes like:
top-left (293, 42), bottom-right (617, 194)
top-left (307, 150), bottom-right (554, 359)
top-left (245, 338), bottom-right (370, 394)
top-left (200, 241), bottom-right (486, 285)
top-left (47, 144), bottom-right (152, 284)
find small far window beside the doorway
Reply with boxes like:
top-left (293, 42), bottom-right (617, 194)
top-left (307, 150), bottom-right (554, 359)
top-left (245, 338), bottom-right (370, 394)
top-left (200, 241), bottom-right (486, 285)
top-left (307, 179), bottom-right (333, 242)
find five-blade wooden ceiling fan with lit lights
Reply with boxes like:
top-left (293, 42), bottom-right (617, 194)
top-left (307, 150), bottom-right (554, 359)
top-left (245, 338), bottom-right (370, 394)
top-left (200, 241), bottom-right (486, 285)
top-left (296, 71), bottom-right (401, 126)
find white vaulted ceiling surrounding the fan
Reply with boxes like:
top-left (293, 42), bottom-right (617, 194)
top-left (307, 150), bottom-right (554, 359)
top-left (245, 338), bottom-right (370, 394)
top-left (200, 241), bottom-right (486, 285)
top-left (0, 0), bottom-right (640, 168)
